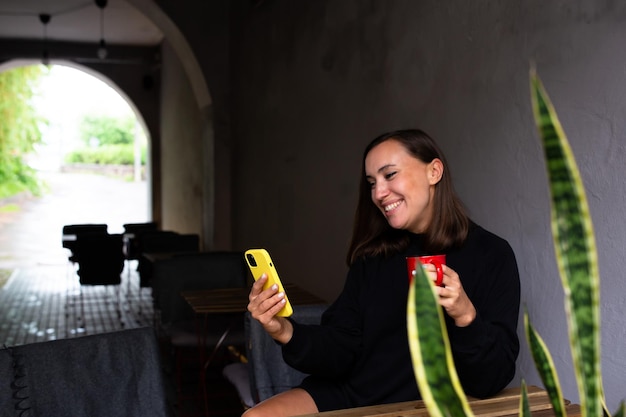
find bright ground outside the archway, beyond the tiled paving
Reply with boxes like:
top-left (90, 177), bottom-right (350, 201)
top-left (0, 172), bottom-right (148, 269)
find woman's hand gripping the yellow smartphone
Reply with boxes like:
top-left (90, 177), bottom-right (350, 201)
top-left (248, 274), bottom-right (293, 344)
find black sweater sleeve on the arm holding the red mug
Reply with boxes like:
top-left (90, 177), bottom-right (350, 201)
top-left (446, 230), bottom-right (520, 398)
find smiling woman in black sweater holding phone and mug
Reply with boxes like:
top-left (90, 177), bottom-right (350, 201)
top-left (245, 130), bottom-right (520, 417)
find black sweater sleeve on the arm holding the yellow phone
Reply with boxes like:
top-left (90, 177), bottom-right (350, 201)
top-left (283, 264), bottom-right (363, 378)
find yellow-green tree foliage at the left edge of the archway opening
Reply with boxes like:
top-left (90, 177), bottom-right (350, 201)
top-left (0, 65), bottom-right (47, 198)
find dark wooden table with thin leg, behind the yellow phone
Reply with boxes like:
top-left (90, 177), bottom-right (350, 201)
top-left (181, 283), bottom-right (326, 416)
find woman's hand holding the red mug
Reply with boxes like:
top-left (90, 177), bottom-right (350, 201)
top-left (425, 264), bottom-right (476, 327)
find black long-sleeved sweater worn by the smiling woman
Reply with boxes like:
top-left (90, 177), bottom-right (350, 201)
top-left (283, 224), bottom-right (520, 411)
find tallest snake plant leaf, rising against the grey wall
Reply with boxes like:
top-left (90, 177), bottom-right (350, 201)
top-left (530, 69), bottom-right (604, 417)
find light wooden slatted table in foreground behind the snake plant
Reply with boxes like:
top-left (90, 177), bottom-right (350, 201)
top-left (301, 386), bottom-right (580, 417)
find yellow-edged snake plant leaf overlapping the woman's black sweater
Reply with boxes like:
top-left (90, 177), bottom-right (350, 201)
top-left (407, 268), bottom-right (474, 417)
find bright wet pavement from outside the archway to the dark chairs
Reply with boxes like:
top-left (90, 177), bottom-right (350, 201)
top-left (0, 172), bottom-right (153, 346)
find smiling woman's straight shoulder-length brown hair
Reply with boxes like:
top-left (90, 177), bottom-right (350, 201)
top-left (347, 129), bottom-right (469, 265)
